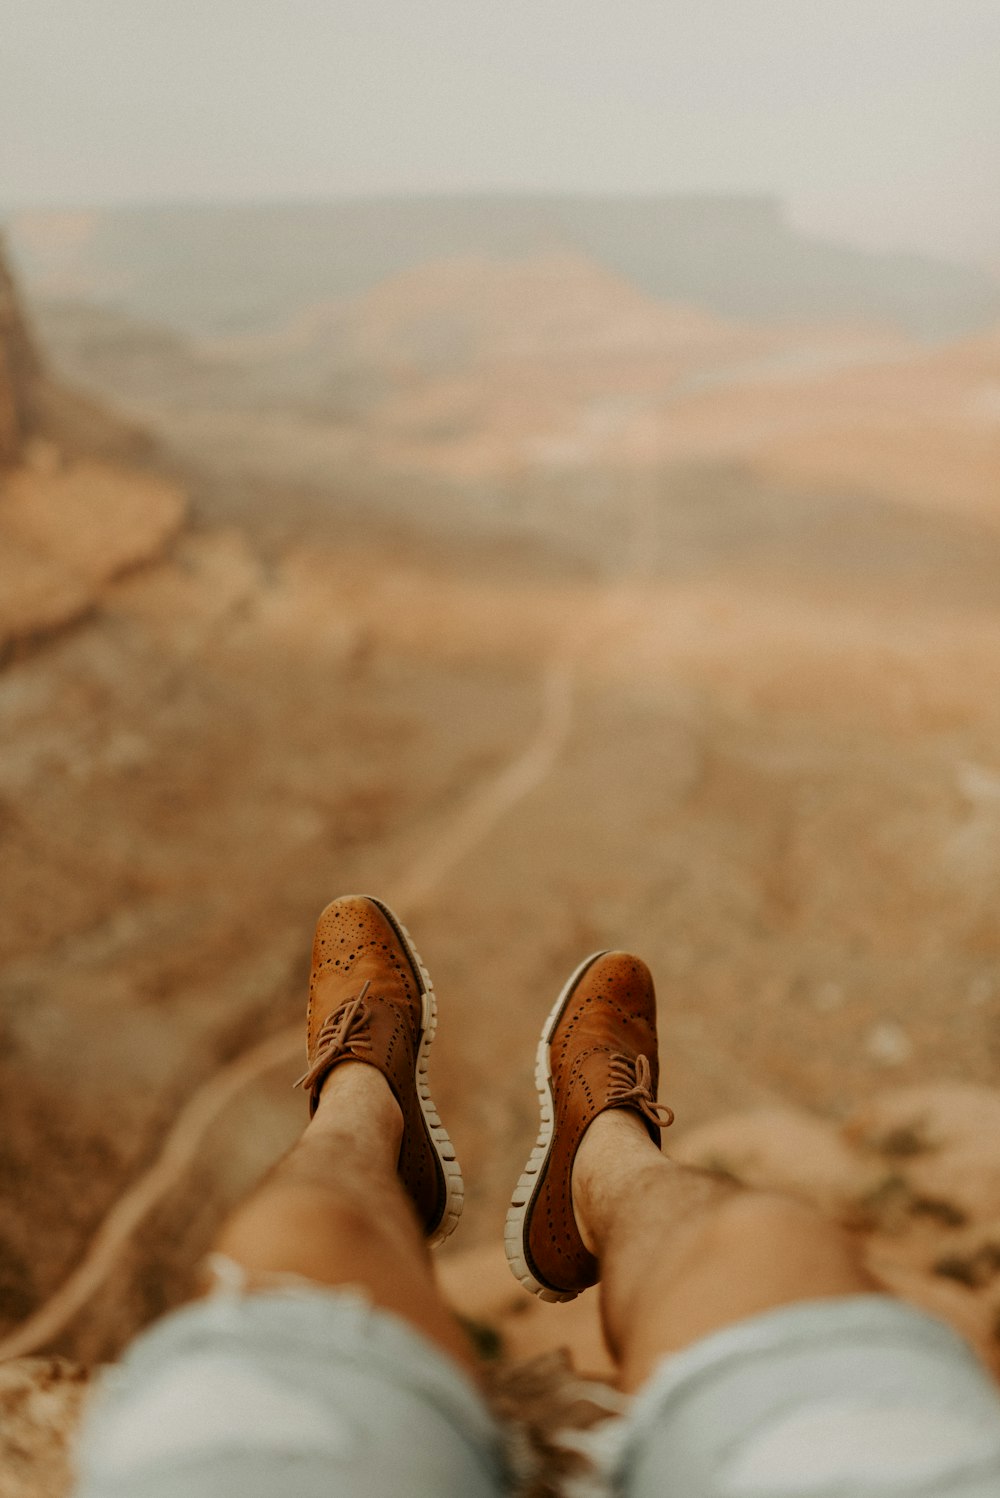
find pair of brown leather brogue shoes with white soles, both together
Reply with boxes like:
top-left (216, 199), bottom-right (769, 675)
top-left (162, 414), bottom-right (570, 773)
top-left (298, 896), bottom-right (672, 1300)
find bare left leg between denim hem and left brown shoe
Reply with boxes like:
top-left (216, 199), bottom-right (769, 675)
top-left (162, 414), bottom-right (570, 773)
top-left (216, 1062), bottom-right (473, 1369)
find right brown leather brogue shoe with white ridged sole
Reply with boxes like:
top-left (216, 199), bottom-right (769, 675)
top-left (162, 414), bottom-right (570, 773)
top-left (504, 951), bottom-right (674, 1300)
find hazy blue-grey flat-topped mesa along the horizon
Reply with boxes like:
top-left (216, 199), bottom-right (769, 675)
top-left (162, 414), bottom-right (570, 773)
top-left (9, 195), bottom-right (1000, 339)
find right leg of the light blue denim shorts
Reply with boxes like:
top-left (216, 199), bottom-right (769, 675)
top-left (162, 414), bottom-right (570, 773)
top-left (614, 1296), bottom-right (1000, 1498)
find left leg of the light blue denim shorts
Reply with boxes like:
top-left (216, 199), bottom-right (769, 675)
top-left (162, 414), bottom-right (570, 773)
top-left (78, 1287), bottom-right (504, 1498)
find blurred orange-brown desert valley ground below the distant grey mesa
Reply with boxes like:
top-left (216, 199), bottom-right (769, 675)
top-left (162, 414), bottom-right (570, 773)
top-left (0, 233), bottom-right (1000, 1491)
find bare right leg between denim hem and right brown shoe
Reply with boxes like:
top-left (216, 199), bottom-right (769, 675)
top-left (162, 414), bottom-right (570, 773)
top-left (572, 1109), bottom-right (879, 1389)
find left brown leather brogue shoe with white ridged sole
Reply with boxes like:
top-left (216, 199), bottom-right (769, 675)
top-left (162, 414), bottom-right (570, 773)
top-left (295, 894), bottom-right (464, 1243)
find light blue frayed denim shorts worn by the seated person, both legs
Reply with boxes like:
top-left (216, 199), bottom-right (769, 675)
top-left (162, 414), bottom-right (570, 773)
top-left (78, 1285), bottom-right (1000, 1498)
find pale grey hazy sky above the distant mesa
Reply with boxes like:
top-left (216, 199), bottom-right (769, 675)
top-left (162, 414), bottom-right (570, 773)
top-left (0, 0), bottom-right (1000, 264)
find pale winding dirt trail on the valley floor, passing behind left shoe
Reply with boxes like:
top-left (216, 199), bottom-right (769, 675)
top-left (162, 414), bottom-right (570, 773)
top-left (0, 650), bottom-right (573, 1360)
